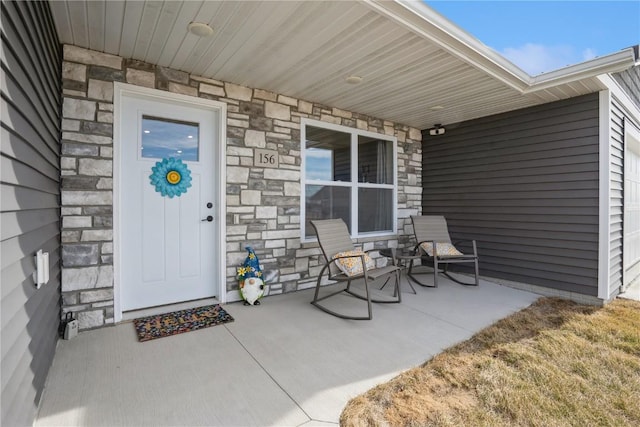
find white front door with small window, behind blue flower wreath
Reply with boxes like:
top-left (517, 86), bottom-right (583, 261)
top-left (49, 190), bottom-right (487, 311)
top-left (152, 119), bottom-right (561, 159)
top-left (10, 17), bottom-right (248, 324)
top-left (119, 90), bottom-right (220, 311)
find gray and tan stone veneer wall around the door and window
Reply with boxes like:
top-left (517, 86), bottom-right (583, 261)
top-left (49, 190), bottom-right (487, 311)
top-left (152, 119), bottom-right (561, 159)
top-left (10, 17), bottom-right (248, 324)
top-left (61, 45), bottom-right (422, 329)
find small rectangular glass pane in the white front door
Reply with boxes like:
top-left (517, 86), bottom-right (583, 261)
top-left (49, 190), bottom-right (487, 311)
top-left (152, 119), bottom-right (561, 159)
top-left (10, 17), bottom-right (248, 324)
top-left (141, 116), bottom-right (199, 162)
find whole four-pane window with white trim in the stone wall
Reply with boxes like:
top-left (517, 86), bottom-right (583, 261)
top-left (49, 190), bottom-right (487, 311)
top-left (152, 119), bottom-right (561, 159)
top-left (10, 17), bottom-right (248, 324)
top-left (301, 120), bottom-right (397, 240)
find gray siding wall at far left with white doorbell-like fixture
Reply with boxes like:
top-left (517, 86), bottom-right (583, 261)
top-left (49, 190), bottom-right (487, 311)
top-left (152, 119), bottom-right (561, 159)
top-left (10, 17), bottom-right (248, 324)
top-left (0, 0), bottom-right (61, 426)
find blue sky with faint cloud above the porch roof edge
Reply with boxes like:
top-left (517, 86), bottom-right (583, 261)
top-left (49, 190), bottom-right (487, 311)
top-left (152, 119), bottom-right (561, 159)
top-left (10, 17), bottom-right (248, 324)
top-left (426, 0), bottom-right (640, 75)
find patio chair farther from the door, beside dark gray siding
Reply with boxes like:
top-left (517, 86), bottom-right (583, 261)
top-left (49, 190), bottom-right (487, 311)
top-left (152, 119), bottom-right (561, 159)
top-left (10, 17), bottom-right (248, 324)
top-left (408, 215), bottom-right (480, 288)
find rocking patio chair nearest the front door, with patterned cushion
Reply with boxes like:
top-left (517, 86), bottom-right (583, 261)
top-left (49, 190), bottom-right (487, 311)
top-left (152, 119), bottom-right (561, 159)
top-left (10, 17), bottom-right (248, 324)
top-left (311, 219), bottom-right (400, 320)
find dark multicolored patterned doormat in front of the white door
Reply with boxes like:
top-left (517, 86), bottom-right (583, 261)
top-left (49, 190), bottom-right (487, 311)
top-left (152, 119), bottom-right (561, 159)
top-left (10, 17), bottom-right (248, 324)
top-left (133, 304), bottom-right (233, 342)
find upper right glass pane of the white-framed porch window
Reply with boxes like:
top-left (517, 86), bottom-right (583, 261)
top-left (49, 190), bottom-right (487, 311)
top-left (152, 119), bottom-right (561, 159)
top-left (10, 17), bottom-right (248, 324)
top-left (358, 136), bottom-right (393, 184)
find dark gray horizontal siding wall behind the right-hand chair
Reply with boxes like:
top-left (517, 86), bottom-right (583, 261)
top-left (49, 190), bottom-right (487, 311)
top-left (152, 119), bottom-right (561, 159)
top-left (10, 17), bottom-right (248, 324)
top-left (422, 94), bottom-right (599, 295)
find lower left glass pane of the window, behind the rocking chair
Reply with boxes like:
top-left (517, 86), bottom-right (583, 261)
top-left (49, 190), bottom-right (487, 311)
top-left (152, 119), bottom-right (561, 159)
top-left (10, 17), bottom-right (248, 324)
top-left (304, 185), bottom-right (351, 241)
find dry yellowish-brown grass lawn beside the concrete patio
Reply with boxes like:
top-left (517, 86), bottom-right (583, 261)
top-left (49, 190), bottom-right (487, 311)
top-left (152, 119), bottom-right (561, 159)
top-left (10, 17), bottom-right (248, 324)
top-left (340, 298), bottom-right (640, 427)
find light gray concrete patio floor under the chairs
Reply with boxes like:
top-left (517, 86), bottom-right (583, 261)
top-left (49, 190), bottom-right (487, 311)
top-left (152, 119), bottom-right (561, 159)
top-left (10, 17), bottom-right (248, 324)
top-left (35, 277), bottom-right (539, 426)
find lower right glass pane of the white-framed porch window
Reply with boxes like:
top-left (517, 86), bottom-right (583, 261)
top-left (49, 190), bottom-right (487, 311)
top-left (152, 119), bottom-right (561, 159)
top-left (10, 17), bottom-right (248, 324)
top-left (358, 188), bottom-right (393, 233)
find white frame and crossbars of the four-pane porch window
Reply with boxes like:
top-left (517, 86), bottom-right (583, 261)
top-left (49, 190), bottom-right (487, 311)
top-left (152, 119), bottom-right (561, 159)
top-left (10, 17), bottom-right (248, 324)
top-left (300, 118), bottom-right (398, 243)
